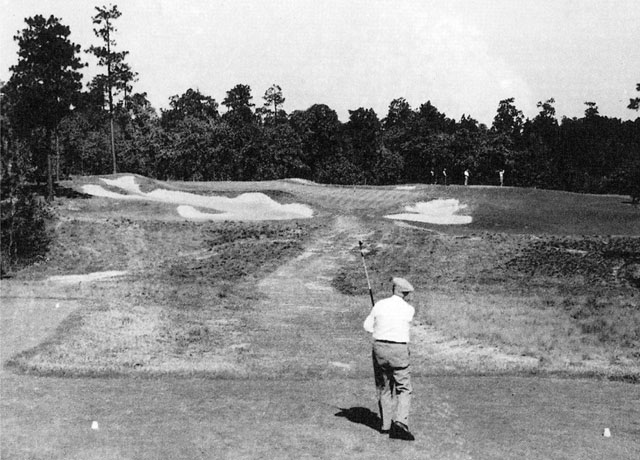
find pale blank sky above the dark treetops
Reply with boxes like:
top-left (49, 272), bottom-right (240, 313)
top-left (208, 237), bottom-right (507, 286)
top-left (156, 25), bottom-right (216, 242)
top-left (0, 0), bottom-right (640, 125)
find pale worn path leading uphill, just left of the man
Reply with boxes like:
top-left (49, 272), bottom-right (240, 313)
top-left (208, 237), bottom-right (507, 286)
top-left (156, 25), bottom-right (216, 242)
top-left (245, 216), bottom-right (376, 377)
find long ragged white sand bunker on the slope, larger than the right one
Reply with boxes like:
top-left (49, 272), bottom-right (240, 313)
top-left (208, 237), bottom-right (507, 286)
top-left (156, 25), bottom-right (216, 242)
top-left (82, 176), bottom-right (313, 221)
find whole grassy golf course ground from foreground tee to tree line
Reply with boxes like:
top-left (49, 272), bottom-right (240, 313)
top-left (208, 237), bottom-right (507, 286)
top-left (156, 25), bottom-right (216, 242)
top-left (0, 175), bottom-right (640, 459)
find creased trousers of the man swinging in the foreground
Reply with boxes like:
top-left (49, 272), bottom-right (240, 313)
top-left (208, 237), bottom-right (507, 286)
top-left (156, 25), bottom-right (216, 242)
top-left (372, 341), bottom-right (413, 430)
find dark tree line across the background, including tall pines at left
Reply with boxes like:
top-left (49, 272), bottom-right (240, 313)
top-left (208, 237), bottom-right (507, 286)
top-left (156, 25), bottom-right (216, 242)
top-left (2, 6), bottom-right (640, 193)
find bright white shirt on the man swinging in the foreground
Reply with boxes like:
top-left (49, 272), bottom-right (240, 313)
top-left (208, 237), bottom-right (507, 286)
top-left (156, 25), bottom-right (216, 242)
top-left (363, 295), bottom-right (415, 343)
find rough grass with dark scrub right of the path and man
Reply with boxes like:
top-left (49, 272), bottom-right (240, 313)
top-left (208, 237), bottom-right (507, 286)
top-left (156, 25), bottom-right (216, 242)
top-left (333, 228), bottom-right (640, 369)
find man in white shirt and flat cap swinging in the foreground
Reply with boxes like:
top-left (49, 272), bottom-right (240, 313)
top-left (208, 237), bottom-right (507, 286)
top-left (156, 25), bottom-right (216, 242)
top-left (364, 278), bottom-right (415, 441)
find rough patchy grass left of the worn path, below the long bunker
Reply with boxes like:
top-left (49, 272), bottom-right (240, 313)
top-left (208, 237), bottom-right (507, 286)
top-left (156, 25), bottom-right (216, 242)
top-left (8, 218), bottom-right (317, 377)
